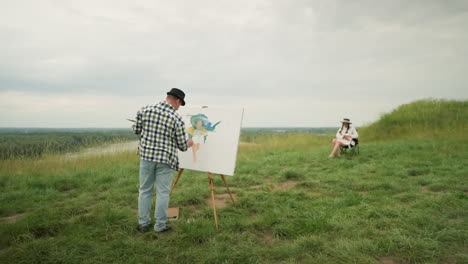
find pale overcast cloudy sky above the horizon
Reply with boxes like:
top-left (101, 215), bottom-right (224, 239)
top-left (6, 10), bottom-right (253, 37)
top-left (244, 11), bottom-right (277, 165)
top-left (0, 0), bottom-right (468, 127)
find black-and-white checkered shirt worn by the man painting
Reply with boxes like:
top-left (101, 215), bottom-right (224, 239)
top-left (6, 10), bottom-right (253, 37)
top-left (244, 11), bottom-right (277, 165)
top-left (132, 101), bottom-right (188, 170)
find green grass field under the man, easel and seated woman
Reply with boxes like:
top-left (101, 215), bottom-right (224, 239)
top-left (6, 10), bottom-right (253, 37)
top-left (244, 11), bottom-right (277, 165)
top-left (0, 99), bottom-right (468, 264)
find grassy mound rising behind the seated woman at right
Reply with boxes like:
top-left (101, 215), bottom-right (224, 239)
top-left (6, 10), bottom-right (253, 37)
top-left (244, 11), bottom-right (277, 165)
top-left (359, 99), bottom-right (468, 141)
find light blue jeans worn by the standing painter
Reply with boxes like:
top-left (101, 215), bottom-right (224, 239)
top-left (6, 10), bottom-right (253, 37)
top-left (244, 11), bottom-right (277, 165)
top-left (138, 159), bottom-right (174, 231)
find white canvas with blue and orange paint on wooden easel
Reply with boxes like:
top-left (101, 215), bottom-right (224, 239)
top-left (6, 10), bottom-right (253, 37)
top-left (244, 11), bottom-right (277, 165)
top-left (178, 107), bottom-right (243, 176)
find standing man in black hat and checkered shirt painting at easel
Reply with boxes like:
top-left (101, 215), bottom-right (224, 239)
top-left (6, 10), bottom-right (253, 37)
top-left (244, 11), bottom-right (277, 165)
top-left (133, 88), bottom-right (193, 232)
